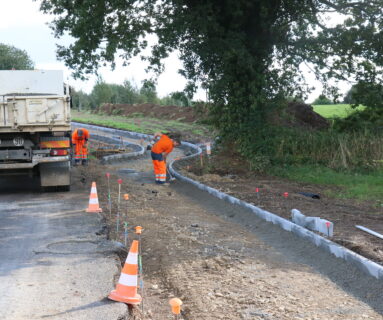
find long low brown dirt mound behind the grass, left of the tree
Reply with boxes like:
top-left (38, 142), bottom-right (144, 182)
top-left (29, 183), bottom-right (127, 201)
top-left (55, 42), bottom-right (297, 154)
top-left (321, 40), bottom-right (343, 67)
top-left (98, 103), bottom-right (199, 123)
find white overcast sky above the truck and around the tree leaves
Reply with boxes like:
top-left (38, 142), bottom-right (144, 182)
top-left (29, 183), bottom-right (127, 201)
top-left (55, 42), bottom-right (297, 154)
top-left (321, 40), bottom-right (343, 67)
top-left (0, 0), bottom-right (348, 102)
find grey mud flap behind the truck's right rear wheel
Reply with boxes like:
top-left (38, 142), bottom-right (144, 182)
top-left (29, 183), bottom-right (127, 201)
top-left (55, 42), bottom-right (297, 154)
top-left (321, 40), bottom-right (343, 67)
top-left (39, 161), bottom-right (70, 190)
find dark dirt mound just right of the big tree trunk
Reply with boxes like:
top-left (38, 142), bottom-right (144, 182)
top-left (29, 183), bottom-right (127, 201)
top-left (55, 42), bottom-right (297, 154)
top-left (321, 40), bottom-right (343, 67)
top-left (285, 102), bottom-right (329, 130)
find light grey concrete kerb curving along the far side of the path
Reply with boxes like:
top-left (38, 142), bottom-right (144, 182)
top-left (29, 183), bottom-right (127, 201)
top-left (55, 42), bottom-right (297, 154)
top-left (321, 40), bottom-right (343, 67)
top-left (72, 122), bottom-right (383, 280)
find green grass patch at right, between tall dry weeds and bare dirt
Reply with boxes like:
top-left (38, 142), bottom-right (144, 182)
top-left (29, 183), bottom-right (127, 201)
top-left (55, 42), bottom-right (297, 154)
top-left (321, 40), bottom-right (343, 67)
top-left (270, 166), bottom-right (383, 206)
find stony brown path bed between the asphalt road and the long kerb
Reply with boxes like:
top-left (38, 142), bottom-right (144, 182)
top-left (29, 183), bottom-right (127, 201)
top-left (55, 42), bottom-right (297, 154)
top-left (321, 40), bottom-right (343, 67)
top-left (78, 150), bottom-right (383, 320)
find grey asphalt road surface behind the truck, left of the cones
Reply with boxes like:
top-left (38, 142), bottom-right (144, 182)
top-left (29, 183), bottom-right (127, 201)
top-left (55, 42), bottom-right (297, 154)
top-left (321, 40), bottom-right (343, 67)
top-left (0, 177), bottom-right (126, 320)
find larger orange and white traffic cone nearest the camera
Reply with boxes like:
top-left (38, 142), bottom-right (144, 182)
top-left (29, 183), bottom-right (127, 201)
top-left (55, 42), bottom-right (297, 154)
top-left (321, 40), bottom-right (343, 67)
top-left (108, 240), bottom-right (141, 304)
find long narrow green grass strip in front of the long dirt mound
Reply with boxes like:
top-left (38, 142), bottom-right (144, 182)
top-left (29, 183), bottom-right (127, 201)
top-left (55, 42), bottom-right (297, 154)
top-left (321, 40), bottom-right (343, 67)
top-left (72, 110), bottom-right (212, 138)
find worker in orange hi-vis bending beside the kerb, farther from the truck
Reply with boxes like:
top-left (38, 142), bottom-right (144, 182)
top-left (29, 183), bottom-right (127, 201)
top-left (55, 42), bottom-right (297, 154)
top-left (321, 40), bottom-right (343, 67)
top-left (151, 132), bottom-right (181, 184)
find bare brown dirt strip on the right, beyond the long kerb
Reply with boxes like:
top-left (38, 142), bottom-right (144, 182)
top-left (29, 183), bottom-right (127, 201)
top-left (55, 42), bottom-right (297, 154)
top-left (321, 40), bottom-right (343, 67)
top-left (178, 151), bottom-right (383, 264)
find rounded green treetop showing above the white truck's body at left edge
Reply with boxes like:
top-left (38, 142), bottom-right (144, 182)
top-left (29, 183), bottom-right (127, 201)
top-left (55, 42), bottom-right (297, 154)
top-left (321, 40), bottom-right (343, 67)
top-left (0, 43), bottom-right (34, 70)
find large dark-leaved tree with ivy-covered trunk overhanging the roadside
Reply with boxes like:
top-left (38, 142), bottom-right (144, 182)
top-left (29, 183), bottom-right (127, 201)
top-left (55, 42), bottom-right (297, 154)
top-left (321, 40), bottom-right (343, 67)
top-left (41, 0), bottom-right (383, 162)
